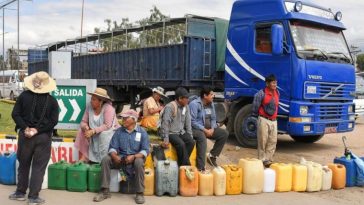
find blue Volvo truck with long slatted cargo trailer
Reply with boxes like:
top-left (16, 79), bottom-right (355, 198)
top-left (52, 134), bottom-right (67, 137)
top-left (29, 0), bottom-right (355, 147)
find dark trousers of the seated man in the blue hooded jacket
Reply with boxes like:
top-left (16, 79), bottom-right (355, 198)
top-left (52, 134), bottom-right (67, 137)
top-left (192, 127), bottom-right (229, 169)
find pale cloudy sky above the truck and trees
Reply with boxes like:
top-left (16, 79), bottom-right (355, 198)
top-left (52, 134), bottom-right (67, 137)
top-left (0, 0), bottom-right (364, 55)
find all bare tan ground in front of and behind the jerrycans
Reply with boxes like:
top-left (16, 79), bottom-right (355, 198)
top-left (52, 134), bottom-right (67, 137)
top-left (0, 119), bottom-right (364, 205)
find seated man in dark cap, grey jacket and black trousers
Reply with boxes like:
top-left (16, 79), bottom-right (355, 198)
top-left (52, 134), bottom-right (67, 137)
top-left (159, 87), bottom-right (195, 166)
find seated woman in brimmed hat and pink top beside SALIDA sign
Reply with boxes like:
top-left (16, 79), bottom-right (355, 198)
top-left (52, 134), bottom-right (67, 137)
top-left (75, 88), bottom-right (120, 163)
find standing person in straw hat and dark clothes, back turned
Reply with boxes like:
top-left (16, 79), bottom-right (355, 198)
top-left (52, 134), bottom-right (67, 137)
top-left (9, 71), bottom-right (59, 205)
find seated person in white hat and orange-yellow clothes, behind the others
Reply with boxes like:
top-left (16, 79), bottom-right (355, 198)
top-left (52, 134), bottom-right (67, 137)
top-left (140, 86), bottom-right (164, 130)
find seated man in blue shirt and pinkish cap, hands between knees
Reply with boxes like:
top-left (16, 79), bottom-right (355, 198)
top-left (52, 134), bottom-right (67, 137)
top-left (93, 110), bottom-right (149, 204)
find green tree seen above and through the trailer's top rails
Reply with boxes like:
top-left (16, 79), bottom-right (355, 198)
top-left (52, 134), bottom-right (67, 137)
top-left (94, 6), bottom-right (185, 51)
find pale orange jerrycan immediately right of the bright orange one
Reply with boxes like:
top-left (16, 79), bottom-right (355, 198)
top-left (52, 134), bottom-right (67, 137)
top-left (198, 170), bottom-right (214, 196)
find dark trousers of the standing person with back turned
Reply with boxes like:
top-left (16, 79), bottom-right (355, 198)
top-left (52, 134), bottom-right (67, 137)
top-left (16, 131), bottom-right (52, 198)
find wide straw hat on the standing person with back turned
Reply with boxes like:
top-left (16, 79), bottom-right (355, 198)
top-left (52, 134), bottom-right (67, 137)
top-left (24, 71), bottom-right (57, 93)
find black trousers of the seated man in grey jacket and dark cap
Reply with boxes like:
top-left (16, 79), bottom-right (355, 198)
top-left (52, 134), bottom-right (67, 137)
top-left (169, 133), bottom-right (195, 166)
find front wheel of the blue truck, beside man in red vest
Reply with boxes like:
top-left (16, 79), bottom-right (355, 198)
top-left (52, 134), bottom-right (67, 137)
top-left (234, 104), bottom-right (257, 147)
